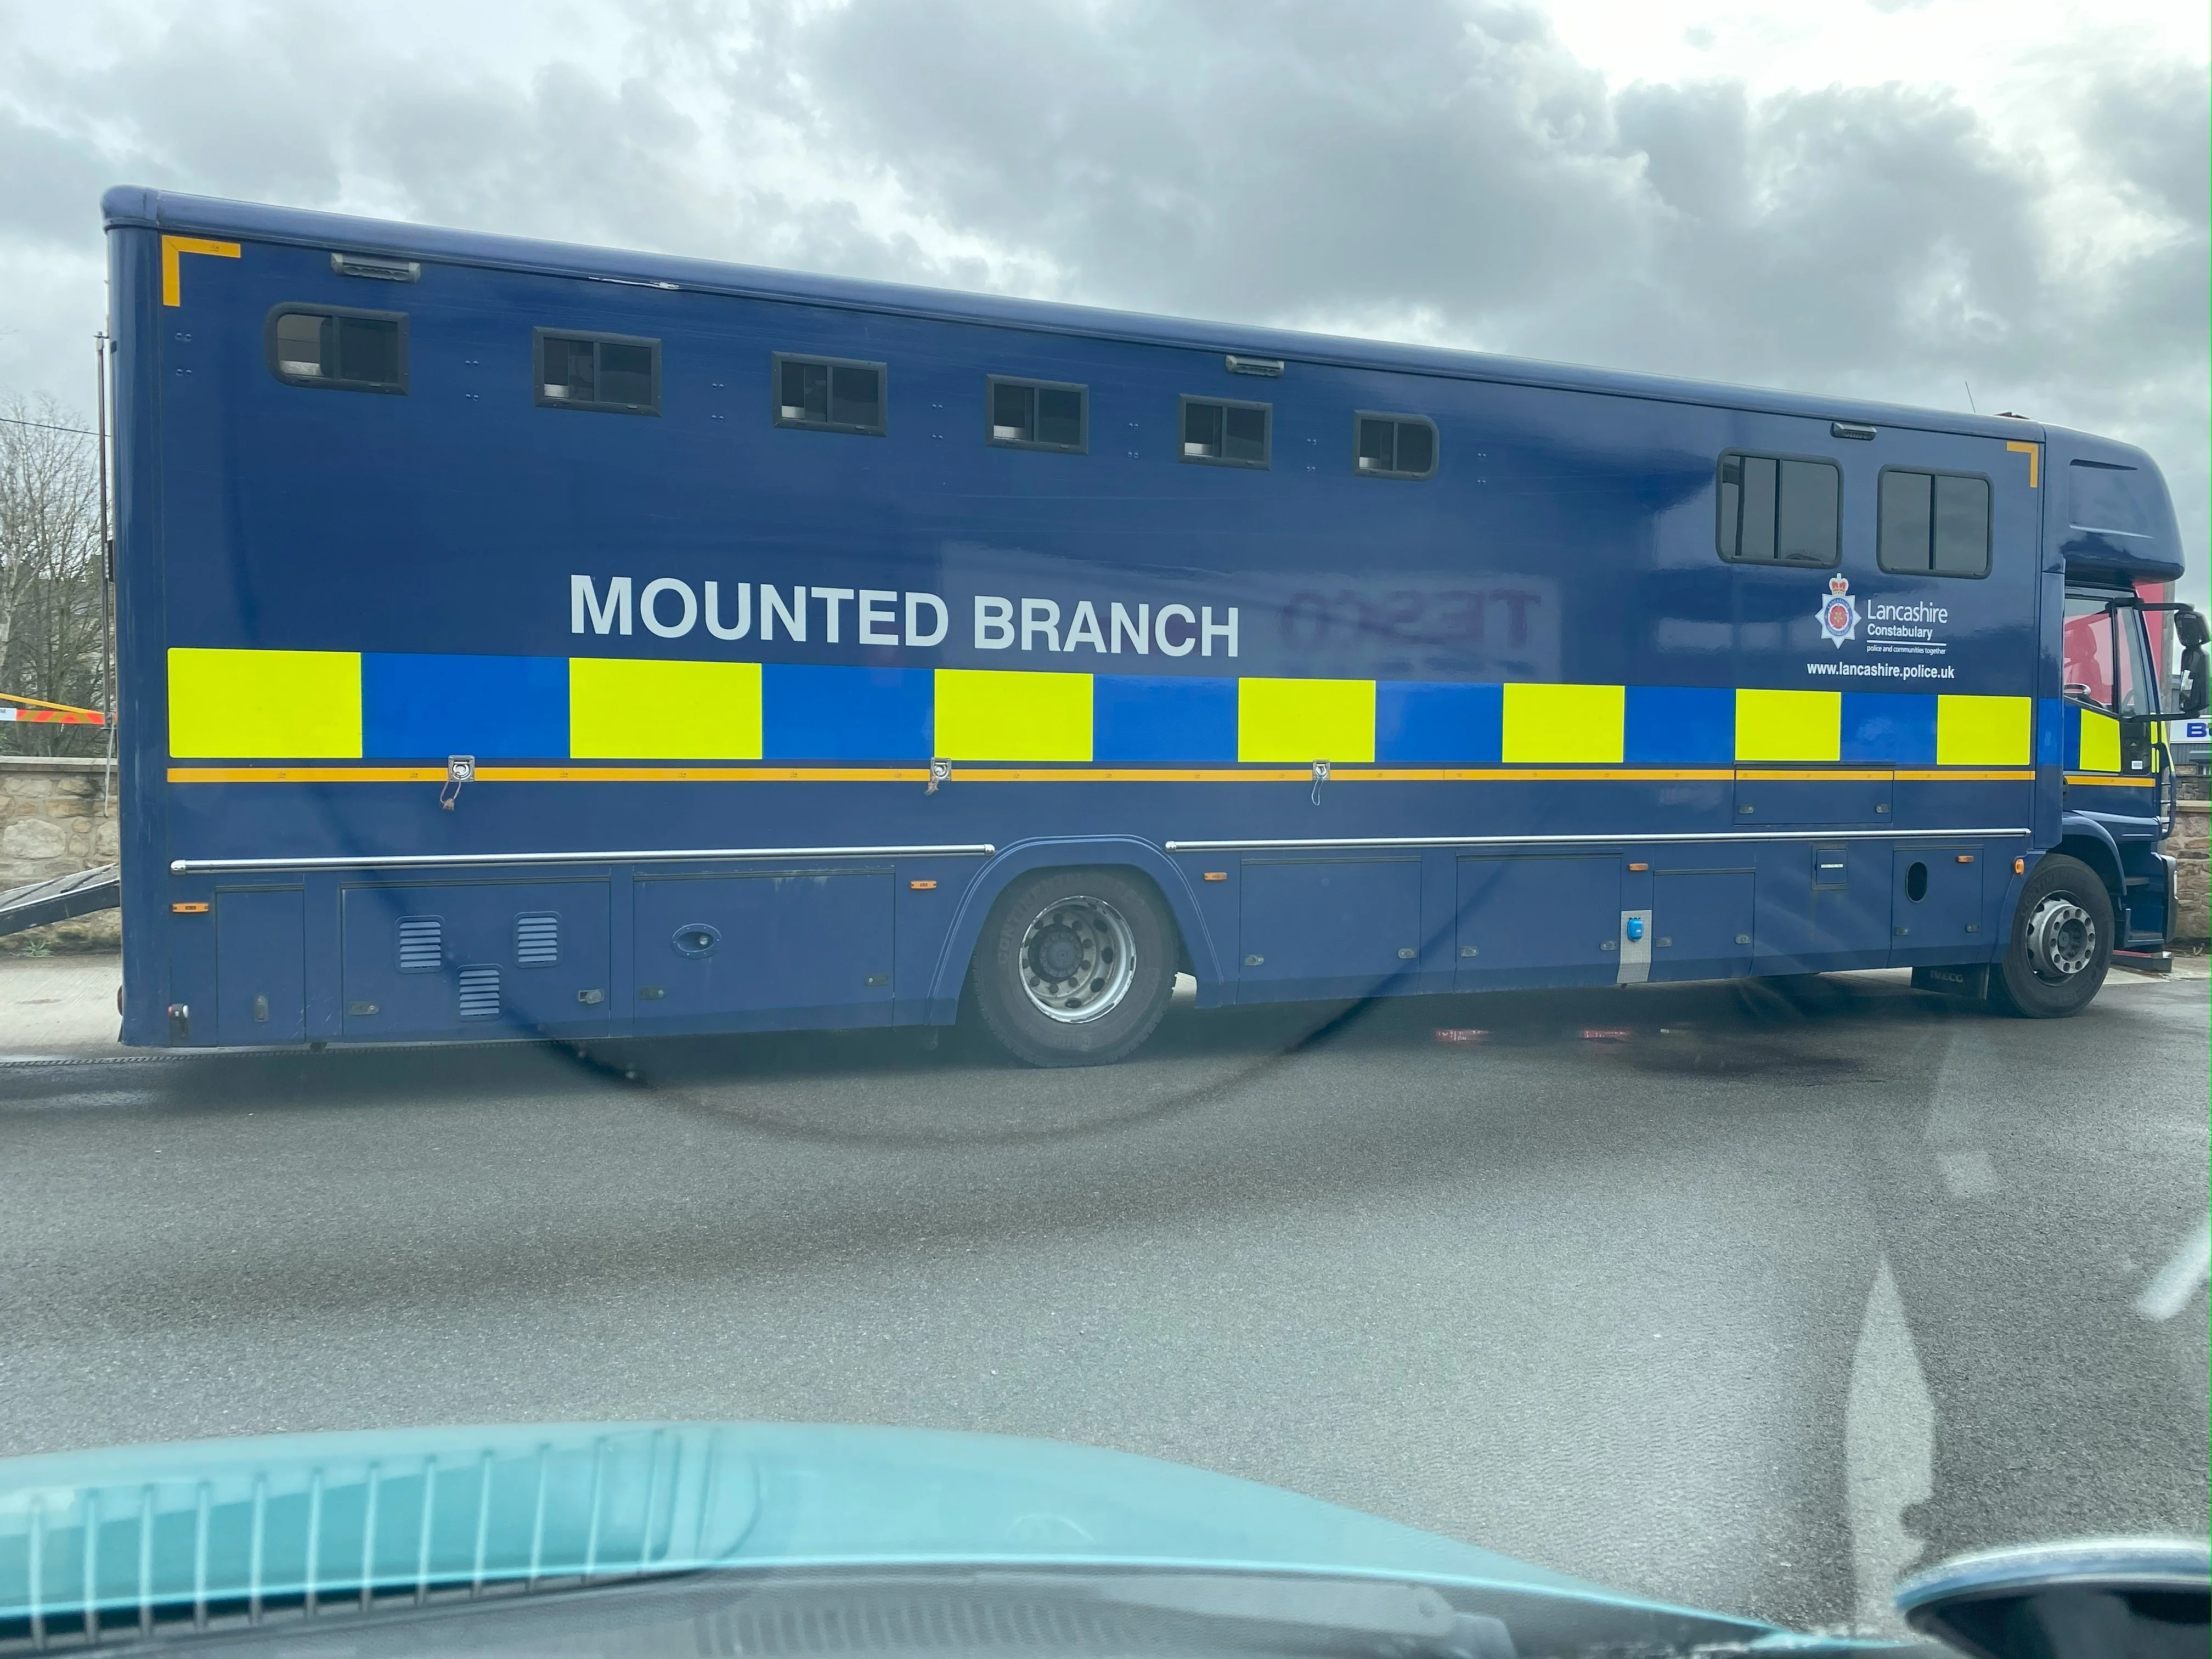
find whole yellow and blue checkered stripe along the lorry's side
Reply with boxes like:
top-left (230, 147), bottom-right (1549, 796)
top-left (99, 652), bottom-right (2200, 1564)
top-left (168, 650), bottom-right (2035, 776)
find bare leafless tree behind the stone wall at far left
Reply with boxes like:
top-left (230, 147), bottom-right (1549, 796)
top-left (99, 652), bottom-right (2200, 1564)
top-left (0, 396), bottom-right (106, 754)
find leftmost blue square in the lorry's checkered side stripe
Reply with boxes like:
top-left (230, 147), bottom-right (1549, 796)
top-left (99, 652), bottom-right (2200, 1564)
top-left (360, 650), bottom-right (568, 761)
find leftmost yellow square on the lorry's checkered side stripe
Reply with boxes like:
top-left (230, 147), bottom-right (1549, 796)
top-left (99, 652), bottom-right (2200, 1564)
top-left (168, 648), bottom-right (360, 761)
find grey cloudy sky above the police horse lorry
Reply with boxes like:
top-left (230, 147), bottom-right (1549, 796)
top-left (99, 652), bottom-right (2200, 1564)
top-left (0, 0), bottom-right (2208, 597)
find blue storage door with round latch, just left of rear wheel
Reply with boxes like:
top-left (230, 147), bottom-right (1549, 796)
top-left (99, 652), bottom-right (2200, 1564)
top-left (630, 870), bottom-right (891, 1031)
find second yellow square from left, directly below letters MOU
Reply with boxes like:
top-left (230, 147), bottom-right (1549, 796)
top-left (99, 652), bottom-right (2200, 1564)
top-left (568, 657), bottom-right (761, 761)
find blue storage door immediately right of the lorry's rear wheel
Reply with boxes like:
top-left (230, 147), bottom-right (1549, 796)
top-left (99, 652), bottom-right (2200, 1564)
top-left (1239, 858), bottom-right (1420, 1002)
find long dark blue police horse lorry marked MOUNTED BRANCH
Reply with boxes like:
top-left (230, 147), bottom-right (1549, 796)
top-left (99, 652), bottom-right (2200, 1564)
top-left (104, 188), bottom-right (2203, 1064)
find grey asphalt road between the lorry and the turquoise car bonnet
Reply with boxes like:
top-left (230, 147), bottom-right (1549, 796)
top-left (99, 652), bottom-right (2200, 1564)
top-left (0, 975), bottom-right (2208, 1626)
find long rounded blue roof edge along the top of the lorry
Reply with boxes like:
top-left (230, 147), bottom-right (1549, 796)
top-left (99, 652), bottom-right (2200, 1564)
top-left (99, 186), bottom-right (2044, 442)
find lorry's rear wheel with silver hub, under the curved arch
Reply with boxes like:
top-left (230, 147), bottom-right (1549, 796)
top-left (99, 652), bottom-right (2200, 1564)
top-left (975, 870), bottom-right (1175, 1066)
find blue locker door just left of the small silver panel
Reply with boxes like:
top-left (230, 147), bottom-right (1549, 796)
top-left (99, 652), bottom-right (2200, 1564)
top-left (1453, 854), bottom-right (1621, 991)
